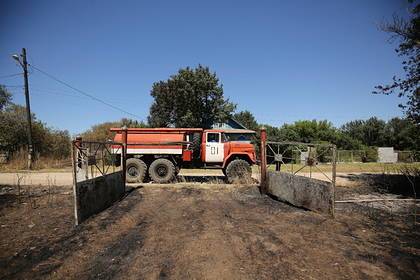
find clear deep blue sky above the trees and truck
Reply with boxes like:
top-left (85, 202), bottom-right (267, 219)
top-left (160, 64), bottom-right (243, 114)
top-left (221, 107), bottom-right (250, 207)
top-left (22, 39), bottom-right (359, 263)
top-left (0, 0), bottom-right (407, 134)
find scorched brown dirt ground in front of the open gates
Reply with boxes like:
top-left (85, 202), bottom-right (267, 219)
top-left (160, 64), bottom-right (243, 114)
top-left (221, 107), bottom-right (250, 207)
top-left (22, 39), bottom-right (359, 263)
top-left (0, 184), bottom-right (420, 280)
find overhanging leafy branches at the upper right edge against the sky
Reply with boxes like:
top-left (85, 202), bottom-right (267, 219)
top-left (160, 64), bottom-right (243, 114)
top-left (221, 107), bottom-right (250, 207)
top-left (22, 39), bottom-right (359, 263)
top-left (374, 1), bottom-right (420, 124)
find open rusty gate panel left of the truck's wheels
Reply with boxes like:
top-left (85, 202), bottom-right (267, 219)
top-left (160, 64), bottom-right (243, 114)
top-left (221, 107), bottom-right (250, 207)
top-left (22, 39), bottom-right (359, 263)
top-left (72, 138), bottom-right (126, 225)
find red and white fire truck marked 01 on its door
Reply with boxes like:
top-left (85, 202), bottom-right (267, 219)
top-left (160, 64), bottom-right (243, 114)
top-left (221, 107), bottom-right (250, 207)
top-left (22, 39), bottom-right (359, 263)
top-left (111, 128), bottom-right (256, 183)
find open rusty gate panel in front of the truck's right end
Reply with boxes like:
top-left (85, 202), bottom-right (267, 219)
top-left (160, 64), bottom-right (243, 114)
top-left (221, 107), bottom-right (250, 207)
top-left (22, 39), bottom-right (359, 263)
top-left (260, 130), bottom-right (336, 216)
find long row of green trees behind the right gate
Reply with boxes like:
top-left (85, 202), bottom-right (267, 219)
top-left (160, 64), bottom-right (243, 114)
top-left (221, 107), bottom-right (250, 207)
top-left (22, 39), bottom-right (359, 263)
top-left (238, 111), bottom-right (420, 151)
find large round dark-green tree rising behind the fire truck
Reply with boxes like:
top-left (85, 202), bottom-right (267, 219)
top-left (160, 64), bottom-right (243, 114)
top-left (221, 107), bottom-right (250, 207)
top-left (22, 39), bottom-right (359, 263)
top-left (148, 65), bottom-right (235, 128)
